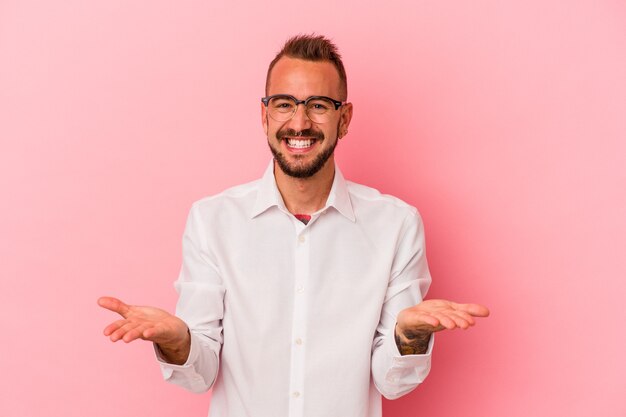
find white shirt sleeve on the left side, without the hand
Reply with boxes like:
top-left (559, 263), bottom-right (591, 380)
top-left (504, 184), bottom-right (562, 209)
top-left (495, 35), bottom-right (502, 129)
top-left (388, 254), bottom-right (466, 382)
top-left (155, 203), bottom-right (225, 392)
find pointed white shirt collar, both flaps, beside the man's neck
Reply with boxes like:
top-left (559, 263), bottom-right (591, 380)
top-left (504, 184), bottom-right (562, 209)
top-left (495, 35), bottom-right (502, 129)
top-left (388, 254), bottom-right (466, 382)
top-left (250, 159), bottom-right (356, 222)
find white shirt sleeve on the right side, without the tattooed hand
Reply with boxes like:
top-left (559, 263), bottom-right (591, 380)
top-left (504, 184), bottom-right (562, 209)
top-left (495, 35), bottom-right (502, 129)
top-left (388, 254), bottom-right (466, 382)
top-left (372, 209), bottom-right (434, 399)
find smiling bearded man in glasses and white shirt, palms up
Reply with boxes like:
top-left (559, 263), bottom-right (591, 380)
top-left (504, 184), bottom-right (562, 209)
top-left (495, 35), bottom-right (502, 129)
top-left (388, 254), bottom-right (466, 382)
top-left (99, 36), bottom-right (488, 417)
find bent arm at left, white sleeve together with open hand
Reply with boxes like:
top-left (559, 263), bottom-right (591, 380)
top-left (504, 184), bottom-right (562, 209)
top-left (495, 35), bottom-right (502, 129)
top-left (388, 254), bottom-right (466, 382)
top-left (98, 204), bottom-right (226, 393)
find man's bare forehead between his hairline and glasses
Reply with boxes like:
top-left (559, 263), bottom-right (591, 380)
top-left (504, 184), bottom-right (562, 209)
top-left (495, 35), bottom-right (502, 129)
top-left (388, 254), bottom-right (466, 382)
top-left (268, 57), bottom-right (340, 99)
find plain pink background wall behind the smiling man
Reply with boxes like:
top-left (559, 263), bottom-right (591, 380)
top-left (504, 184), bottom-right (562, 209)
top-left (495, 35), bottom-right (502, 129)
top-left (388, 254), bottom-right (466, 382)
top-left (0, 0), bottom-right (626, 417)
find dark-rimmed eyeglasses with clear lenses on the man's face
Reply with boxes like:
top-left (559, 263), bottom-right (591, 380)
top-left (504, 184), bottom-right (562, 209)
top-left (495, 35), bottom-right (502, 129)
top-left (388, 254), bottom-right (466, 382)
top-left (261, 94), bottom-right (344, 123)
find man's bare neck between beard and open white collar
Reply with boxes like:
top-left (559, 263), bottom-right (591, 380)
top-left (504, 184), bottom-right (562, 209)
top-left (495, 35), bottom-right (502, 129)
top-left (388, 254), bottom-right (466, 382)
top-left (274, 157), bottom-right (335, 214)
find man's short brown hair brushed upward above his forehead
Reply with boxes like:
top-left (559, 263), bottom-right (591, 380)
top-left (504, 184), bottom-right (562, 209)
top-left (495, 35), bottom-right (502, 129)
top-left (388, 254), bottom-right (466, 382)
top-left (265, 35), bottom-right (348, 101)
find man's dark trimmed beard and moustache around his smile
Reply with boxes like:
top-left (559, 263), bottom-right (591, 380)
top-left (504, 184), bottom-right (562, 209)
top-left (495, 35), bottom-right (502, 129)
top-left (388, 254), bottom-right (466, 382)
top-left (267, 125), bottom-right (339, 178)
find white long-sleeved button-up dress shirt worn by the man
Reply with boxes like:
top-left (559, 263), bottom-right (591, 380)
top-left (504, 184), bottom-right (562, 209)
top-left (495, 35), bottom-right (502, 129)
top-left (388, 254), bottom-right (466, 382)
top-left (157, 162), bottom-right (433, 417)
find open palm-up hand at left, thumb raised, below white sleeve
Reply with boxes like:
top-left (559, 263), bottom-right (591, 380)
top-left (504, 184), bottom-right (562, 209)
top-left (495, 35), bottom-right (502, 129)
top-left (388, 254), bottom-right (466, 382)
top-left (98, 297), bottom-right (191, 365)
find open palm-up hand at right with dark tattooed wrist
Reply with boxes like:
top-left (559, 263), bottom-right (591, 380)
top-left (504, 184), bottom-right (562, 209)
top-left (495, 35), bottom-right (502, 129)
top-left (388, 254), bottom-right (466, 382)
top-left (395, 300), bottom-right (489, 355)
